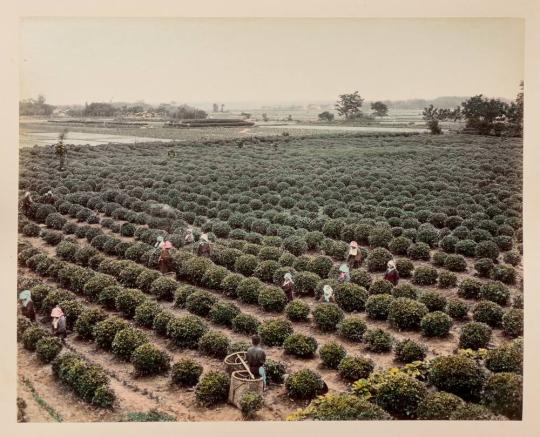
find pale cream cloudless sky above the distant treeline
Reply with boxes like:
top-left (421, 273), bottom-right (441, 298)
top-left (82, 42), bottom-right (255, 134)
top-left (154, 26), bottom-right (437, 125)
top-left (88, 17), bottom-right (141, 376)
top-left (20, 18), bottom-right (524, 104)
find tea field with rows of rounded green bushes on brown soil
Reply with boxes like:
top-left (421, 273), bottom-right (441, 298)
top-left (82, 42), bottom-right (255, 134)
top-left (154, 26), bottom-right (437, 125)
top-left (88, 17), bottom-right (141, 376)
top-left (17, 134), bottom-right (523, 421)
